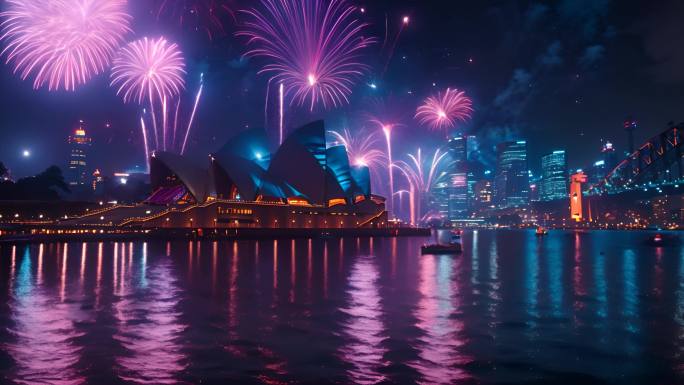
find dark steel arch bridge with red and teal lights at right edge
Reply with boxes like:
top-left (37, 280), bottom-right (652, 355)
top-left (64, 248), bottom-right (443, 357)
top-left (587, 122), bottom-right (684, 195)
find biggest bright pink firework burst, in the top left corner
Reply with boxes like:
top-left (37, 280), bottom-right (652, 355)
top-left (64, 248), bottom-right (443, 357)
top-left (0, 0), bottom-right (131, 91)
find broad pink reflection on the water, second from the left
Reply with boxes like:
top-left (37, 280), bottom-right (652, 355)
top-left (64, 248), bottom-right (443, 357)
top-left (114, 252), bottom-right (187, 384)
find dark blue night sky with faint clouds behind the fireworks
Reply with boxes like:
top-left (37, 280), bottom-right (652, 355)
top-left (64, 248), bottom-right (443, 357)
top-left (0, 0), bottom-right (684, 176)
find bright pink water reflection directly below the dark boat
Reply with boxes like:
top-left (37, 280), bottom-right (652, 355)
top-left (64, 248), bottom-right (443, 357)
top-left (411, 256), bottom-right (470, 384)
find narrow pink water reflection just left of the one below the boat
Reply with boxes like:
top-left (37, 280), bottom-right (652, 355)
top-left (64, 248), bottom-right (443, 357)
top-left (340, 256), bottom-right (387, 384)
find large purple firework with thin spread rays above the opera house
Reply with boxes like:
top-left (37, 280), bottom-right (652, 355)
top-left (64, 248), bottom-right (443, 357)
top-left (238, 0), bottom-right (375, 110)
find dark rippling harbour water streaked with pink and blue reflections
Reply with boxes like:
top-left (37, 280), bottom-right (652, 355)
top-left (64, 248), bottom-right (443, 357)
top-left (0, 230), bottom-right (684, 384)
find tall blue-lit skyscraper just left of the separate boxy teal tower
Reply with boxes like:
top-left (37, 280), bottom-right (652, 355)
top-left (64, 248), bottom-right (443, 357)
top-left (494, 140), bottom-right (530, 208)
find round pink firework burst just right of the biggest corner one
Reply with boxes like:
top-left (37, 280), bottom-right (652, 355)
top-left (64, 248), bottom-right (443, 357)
top-left (111, 37), bottom-right (185, 105)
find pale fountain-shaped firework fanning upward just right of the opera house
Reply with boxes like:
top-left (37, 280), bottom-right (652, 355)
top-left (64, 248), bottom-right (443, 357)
top-left (394, 148), bottom-right (452, 225)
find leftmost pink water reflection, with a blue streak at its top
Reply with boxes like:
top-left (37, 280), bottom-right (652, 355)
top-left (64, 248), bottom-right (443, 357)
top-left (3, 245), bottom-right (85, 384)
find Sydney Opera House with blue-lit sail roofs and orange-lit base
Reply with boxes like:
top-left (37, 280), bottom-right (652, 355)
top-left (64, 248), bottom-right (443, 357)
top-left (62, 121), bottom-right (387, 228)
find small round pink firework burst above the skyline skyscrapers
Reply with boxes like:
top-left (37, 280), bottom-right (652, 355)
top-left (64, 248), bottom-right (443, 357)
top-left (415, 88), bottom-right (473, 130)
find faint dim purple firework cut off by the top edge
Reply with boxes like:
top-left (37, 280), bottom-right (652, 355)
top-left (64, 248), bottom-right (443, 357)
top-left (152, 0), bottom-right (235, 40)
